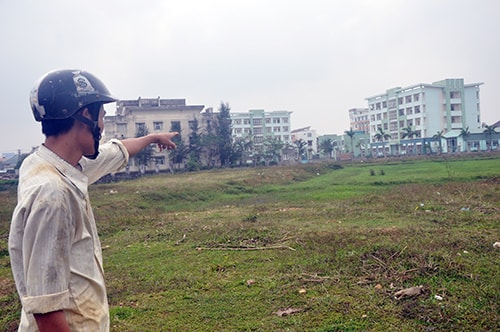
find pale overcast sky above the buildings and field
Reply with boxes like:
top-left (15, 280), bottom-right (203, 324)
top-left (0, 0), bottom-right (500, 153)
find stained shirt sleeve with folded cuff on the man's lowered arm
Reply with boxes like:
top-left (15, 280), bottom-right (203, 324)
top-left (21, 183), bottom-right (74, 313)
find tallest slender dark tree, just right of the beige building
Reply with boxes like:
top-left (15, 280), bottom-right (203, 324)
top-left (214, 102), bottom-right (232, 167)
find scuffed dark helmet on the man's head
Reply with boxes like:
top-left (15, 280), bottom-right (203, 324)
top-left (30, 69), bottom-right (117, 121)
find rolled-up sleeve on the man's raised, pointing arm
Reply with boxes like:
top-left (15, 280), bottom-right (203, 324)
top-left (80, 139), bottom-right (129, 184)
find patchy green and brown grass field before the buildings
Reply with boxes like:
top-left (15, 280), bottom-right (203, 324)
top-left (0, 158), bottom-right (500, 332)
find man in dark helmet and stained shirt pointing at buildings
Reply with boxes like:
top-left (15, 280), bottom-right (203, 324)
top-left (9, 70), bottom-right (177, 332)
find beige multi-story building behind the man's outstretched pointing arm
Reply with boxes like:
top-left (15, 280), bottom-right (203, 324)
top-left (104, 97), bottom-right (206, 171)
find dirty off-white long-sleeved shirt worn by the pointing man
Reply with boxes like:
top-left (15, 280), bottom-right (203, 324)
top-left (9, 140), bottom-right (129, 331)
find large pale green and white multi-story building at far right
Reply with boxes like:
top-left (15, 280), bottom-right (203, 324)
top-left (366, 79), bottom-right (483, 155)
